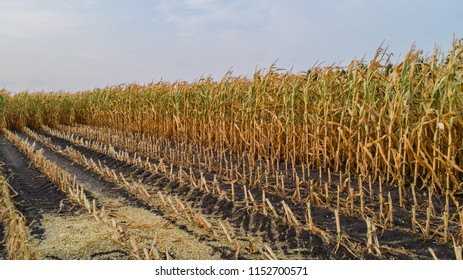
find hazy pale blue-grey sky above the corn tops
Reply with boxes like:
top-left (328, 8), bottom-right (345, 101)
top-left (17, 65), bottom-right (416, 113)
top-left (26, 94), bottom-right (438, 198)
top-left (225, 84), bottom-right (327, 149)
top-left (0, 0), bottom-right (463, 91)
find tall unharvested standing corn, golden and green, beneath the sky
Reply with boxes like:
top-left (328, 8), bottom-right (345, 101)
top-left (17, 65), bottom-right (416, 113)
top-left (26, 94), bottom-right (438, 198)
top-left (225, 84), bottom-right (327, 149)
top-left (0, 40), bottom-right (463, 193)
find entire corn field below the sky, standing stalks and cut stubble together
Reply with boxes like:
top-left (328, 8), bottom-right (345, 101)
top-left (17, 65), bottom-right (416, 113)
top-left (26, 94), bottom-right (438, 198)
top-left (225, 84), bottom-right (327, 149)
top-left (0, 41), bottom-right (463, 260)
